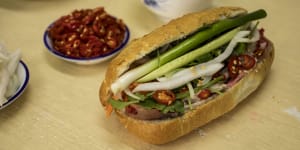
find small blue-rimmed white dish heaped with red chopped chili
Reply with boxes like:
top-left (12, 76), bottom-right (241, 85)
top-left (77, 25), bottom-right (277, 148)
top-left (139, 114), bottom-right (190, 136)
top-left (43, 7), bottom-right (130, 64)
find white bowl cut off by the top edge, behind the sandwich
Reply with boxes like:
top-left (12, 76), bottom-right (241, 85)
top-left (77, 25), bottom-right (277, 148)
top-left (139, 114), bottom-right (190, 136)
top-left (141, 0), bottom-right (212, 22)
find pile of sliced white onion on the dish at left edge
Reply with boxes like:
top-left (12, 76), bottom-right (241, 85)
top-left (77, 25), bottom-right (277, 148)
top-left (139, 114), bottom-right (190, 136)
top-left (0, 45), bottom-right (21, 106)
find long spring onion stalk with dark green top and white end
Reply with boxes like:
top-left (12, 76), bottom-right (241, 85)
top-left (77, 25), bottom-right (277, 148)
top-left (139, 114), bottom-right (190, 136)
top-left (111, 9), bottom-right (267, 94)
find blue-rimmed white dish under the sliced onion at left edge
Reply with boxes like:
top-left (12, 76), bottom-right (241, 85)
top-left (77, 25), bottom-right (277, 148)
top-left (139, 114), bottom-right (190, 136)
top-left (0, 61), bottom-right (29, 110)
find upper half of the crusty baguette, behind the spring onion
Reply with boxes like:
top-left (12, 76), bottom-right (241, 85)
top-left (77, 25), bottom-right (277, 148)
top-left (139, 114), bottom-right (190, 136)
top-left (99, 7), bottom-right (246, 106)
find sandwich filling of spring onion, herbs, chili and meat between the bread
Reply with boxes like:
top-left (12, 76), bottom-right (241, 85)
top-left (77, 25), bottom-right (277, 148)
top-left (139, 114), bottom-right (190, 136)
top-left (106, 10), bottom-right (268, 120)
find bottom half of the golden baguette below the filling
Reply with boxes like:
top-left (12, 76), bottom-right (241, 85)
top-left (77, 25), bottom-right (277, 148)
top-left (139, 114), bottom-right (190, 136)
top-left (117, 43), bottom-right (274, 144)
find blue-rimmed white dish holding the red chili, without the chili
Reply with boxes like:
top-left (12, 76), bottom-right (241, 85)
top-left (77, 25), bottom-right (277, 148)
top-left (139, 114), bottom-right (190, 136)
top-left (44, 25), bottom-right (130, 65)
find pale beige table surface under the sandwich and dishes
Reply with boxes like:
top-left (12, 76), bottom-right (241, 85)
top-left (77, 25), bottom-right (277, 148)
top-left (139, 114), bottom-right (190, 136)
top-left (0, 0), bottom-right (300, 150)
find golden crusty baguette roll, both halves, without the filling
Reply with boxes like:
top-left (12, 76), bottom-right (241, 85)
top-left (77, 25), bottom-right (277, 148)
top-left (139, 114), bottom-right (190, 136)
top-left (99, 7), bottom-right (274, 144)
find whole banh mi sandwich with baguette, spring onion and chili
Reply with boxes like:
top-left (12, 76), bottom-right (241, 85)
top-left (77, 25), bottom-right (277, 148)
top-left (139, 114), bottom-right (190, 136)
top-left (99, 7), bottom-right (274, 144)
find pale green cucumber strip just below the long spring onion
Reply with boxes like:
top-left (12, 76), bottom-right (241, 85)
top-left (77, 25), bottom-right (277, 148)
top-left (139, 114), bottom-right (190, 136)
top-left (138, 28), bottom-right (240, 82)
